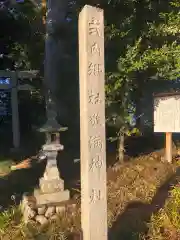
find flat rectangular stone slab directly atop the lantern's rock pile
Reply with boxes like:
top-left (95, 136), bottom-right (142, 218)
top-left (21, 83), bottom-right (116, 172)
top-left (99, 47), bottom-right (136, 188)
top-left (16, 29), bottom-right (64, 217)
top-left (34, 190), bottom-right (70, 207)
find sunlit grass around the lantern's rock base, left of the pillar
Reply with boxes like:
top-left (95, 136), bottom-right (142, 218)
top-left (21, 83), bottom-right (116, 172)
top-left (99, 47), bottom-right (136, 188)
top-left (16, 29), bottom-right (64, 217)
top-left (0, 206), bottom-right (78, 240)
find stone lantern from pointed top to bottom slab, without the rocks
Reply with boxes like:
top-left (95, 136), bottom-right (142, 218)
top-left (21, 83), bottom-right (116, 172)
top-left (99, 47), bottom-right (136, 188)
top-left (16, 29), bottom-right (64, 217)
top-left (35, 93), bottom-right (69, 205)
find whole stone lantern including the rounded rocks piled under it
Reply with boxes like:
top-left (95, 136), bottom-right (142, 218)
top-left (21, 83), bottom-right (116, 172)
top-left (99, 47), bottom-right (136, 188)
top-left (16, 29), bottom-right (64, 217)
top-left (22, 104), bottom-right (70, 224)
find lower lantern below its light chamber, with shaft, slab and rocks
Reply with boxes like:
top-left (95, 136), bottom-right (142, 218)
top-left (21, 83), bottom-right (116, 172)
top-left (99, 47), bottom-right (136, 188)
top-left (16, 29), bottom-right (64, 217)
top-left (22, 143), bottom-right (70, 224)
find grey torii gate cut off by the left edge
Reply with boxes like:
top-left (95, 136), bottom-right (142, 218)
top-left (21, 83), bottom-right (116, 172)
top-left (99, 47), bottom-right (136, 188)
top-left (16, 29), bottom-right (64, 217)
top-left (0, 70), bottom-right (38, 149)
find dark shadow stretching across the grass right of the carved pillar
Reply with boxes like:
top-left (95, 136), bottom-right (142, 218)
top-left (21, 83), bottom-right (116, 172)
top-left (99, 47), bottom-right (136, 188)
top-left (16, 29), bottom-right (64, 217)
top-left (109, 169), bottom-right (180, 240)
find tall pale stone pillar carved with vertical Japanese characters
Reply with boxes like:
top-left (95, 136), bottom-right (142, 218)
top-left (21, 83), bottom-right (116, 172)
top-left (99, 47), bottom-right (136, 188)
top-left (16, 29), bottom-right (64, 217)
top-left (79, 5), bottom-right (107, 240)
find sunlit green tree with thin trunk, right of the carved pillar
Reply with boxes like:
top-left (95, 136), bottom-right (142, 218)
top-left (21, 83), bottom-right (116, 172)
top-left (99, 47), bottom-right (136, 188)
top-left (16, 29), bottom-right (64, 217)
top-left (106, 0), bottom-right (180, 160)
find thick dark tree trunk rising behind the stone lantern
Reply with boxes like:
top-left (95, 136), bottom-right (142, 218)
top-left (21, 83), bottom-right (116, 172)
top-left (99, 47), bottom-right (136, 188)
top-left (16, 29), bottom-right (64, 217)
top-left (44, 0), bottom-right (68, 123)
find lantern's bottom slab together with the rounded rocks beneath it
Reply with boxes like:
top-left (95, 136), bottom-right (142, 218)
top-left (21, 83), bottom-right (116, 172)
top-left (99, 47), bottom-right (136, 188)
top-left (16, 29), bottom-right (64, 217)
top-left (21, 190), bottom-right (71, 225)
